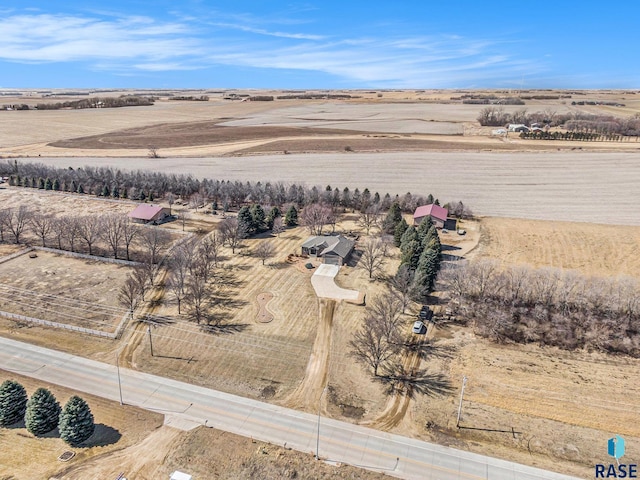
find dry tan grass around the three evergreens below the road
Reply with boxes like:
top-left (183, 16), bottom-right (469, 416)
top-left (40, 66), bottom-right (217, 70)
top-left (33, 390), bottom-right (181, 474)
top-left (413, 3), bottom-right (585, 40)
top-left (0, 372), bottom-right (162, 480)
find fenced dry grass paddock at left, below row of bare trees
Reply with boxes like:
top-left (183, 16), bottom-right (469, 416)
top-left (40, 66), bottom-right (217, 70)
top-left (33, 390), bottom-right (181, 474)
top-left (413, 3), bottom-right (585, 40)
top-left (0, 251), bottom-right (130, 332)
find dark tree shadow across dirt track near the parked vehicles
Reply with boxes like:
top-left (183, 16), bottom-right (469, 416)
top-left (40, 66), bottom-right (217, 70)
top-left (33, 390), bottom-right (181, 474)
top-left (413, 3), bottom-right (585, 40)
top-left (375, 365), bottom-right (453, 398)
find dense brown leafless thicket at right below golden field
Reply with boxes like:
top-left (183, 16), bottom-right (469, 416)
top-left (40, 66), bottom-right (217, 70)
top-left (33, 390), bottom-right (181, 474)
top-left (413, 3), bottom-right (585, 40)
top-left (439, 260), bottom-right (640, 357)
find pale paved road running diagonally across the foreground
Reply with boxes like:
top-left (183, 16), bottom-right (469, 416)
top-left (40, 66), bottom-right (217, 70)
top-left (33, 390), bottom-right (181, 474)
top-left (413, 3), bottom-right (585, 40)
top-left (0, 337), bottom-right (572, 480)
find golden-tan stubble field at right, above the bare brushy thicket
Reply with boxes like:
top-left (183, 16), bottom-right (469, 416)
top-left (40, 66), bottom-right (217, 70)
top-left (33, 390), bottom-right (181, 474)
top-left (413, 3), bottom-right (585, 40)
top-left (477, 218), bottom-right (640, 277)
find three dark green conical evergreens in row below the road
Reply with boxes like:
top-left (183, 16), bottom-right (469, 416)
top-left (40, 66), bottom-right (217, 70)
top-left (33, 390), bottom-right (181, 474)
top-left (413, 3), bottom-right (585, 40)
top-left (0, 380), bottom-right (95, 446)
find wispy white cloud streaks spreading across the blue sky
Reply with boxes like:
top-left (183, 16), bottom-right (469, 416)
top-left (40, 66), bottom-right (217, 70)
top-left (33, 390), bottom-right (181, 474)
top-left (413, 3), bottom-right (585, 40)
top-left (0, 13), bottom-right (543, 88)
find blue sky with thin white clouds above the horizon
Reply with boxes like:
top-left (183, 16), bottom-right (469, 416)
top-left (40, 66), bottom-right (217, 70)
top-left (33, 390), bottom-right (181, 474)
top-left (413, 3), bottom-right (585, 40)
top-left (0, 0), bottom-right (640, 89)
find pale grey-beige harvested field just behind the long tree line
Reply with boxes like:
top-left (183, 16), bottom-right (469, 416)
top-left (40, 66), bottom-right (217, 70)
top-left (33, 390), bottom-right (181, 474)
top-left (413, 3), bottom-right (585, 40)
top-left (32, 152), bottom-right (640, 225)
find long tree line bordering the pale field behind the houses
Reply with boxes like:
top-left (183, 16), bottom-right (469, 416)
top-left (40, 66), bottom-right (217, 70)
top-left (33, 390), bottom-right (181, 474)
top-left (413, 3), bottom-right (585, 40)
top-left (0, 159), bottom-right (458, 212)
